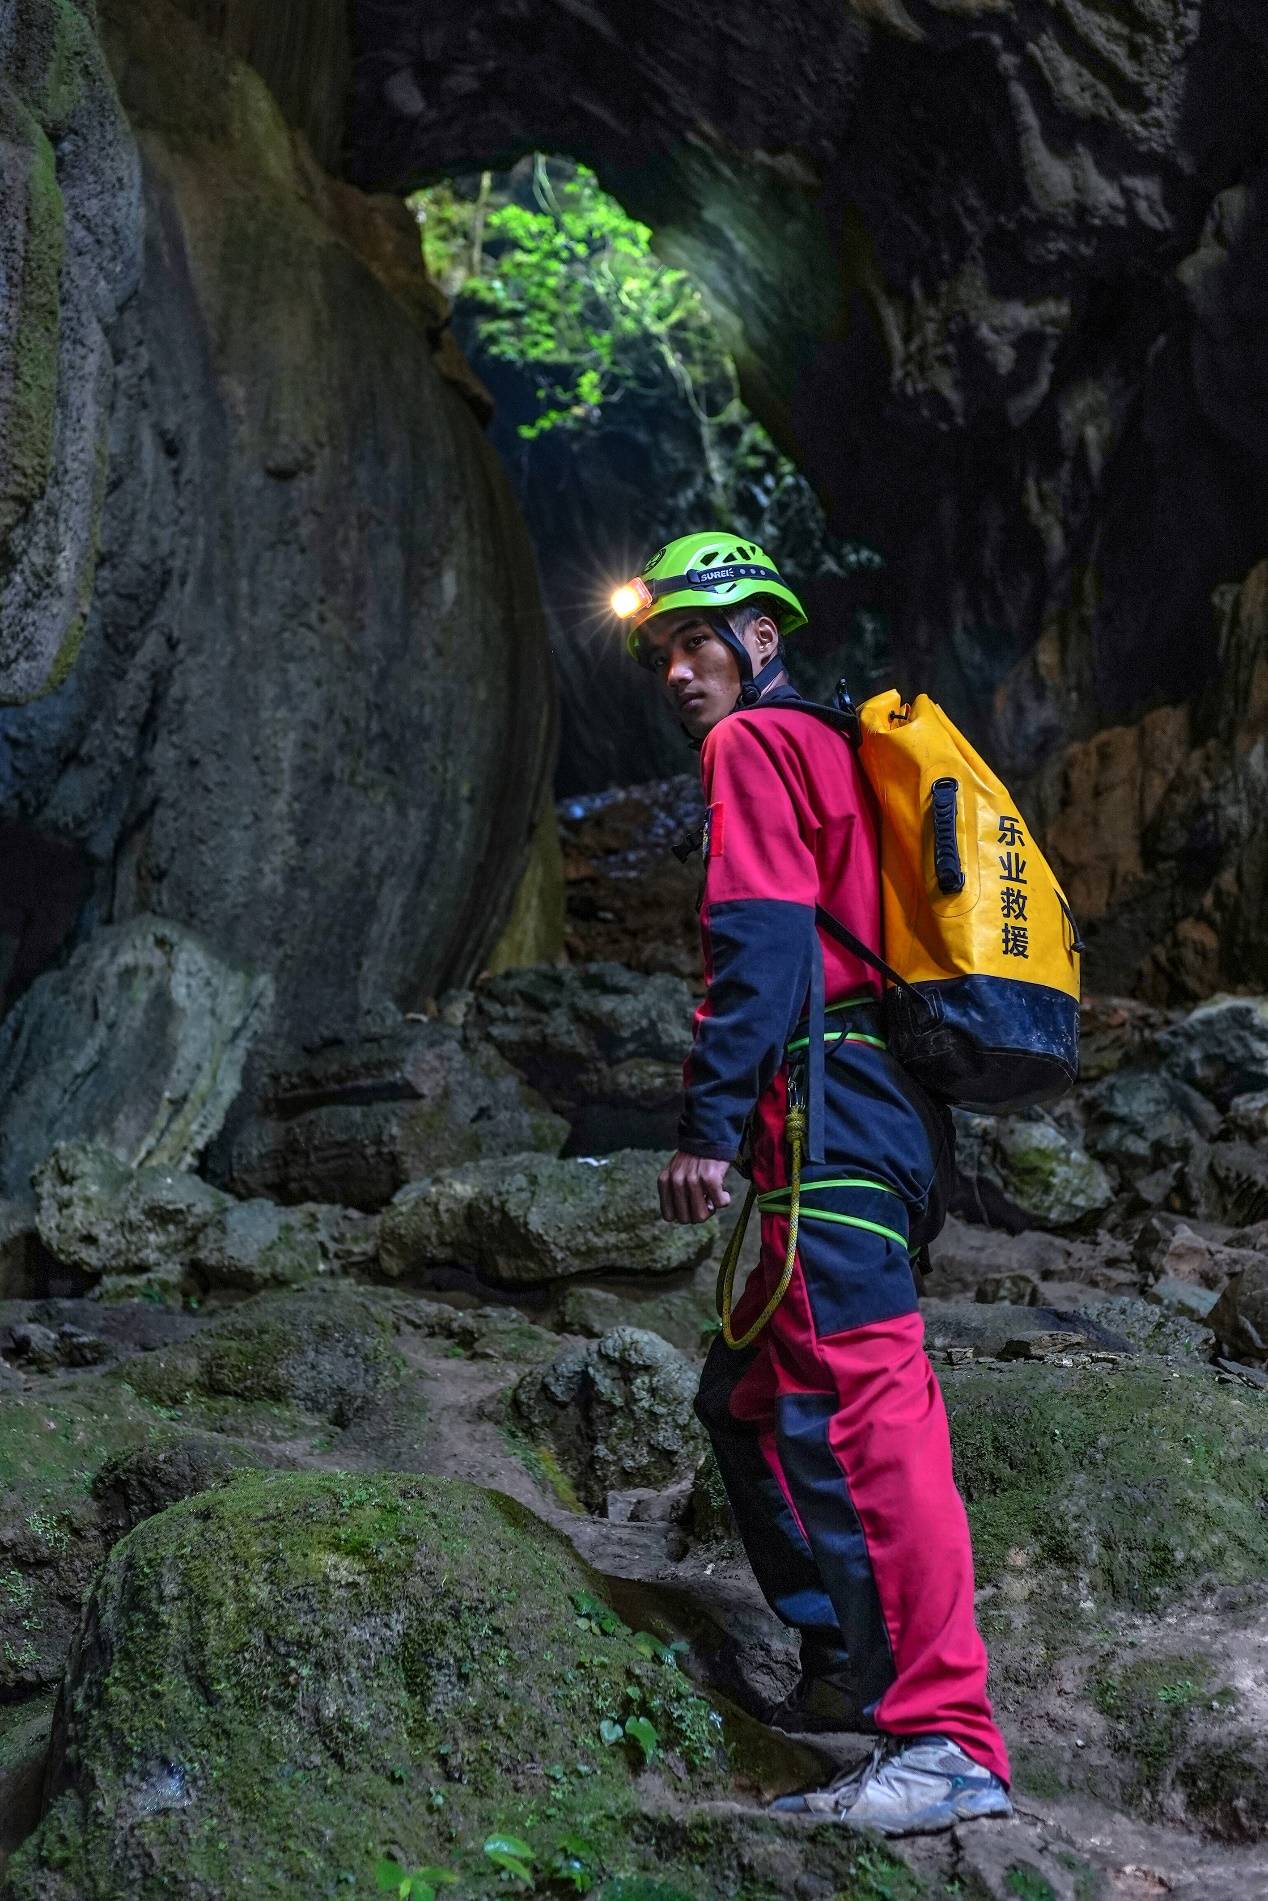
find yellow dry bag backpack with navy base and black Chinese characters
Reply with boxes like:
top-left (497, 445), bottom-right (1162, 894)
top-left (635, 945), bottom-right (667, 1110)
top-left (787, 684), bottom-right (1084, 1116)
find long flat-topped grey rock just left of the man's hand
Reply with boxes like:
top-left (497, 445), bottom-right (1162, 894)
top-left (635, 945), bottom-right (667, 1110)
top-left (378, 1148), bottom-right (715, 1287)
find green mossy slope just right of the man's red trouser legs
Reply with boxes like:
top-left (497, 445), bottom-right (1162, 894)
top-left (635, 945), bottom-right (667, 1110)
top-left (941, 1365), bottom-right (1268, 1639)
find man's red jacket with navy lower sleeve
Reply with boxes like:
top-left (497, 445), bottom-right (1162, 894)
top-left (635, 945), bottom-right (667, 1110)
top-left (679, 692), bottom-right (882, 1162)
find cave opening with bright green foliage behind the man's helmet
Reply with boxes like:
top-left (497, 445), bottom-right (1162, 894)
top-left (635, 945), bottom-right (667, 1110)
top-left (409, 152), bottom-right (890, 797)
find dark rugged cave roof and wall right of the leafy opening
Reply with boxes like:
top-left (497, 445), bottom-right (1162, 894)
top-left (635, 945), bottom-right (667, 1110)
top-left (350, 0), bottom-right (1268, 772)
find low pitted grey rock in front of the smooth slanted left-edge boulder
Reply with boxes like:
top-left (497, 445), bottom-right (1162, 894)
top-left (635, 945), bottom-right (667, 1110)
top-left (36, 1143), bottom-right (375, 1298)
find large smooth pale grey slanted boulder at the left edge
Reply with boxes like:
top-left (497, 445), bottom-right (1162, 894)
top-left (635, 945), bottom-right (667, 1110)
top-left (0, 918), bottom-right (270, 1196)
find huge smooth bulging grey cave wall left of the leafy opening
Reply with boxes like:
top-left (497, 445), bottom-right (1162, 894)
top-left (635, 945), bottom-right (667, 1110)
top-left (0, 0), bottom-right (555, 1040)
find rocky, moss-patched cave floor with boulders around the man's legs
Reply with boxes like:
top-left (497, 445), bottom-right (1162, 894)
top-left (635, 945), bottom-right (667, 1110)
top-left (0, 793), bottom-right (1268, 1901)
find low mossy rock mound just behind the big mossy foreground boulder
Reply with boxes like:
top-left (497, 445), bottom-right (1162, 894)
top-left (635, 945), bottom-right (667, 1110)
top-left (118, 1287), bottom-right (401, 1437)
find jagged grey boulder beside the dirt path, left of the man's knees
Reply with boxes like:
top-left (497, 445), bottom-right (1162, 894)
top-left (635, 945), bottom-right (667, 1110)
top-left (513, 1327), bottom-right (705, 1511)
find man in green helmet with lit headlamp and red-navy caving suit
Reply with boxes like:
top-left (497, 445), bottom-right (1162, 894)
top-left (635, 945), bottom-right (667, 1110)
top-left (612, 532), bottom-right (1011, 1834)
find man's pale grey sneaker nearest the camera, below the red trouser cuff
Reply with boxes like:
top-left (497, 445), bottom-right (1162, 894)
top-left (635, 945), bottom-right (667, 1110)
top-left (772, 1736), bottom-right (1013, 1834)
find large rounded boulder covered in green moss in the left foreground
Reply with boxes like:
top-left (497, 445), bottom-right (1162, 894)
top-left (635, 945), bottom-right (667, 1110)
top-left (6, 1473), bottom-right (874, 1901)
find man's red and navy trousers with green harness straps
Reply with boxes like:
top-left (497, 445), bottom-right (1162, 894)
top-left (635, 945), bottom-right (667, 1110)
top-left (696, 1046), bottom-right (1009, 1781)
